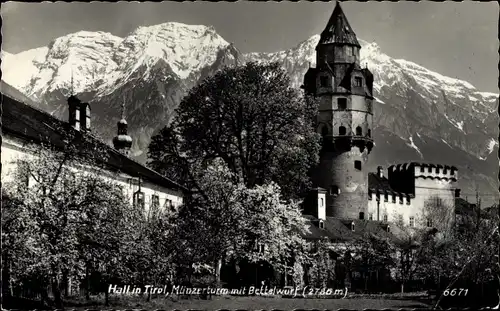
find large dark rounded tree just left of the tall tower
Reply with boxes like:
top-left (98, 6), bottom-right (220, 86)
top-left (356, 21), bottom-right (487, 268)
top-left (148, 63), bottom-right (320, 200)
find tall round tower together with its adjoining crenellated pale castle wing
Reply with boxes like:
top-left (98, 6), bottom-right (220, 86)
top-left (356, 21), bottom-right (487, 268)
top-left (302, 2), bottom-right (459, 232)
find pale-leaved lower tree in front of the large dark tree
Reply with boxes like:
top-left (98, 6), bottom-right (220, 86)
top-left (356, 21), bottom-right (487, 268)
top-left (172, 159), bottom-right (304, 283)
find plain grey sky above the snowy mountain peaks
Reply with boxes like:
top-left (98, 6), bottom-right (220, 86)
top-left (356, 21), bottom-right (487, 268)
top-left (0, 1), bottom-right (499, 93)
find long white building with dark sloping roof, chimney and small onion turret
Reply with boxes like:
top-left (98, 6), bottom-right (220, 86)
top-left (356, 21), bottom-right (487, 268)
top-left (1, 94), bottom-right (187, 214)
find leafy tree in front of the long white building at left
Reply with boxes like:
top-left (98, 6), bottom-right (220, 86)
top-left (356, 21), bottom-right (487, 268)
top-left (2, 129), bottom-right (133, 307)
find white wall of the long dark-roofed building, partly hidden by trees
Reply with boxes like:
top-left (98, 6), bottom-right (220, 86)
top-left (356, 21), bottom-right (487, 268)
top-left (1, 136), bottom-right (183, 213)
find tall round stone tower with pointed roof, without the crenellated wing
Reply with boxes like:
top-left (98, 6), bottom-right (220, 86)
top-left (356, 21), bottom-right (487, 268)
top-left (303, 2), bottom-right (374, 219)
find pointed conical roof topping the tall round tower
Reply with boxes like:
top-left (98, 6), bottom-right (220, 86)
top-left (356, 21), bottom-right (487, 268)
top-left (318, 1), bottom-right (361, 48)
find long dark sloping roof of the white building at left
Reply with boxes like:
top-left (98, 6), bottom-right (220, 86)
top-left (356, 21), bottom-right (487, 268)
top-left (1, 94), bottom-right (187, 191)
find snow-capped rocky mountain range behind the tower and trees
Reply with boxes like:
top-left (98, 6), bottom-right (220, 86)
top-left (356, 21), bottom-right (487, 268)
top-left (1, 22), bottom-right (499, 204)
